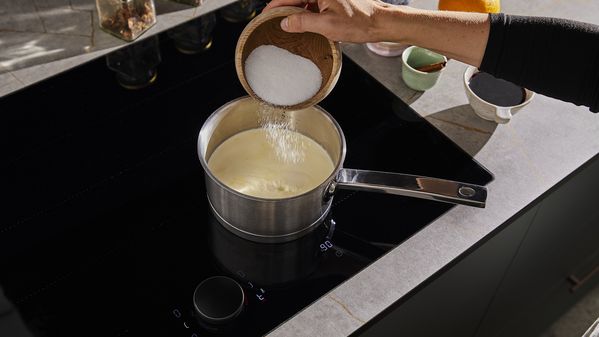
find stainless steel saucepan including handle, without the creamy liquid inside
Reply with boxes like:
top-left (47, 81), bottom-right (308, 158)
top-left (198, 97), bottom-right (487, 242)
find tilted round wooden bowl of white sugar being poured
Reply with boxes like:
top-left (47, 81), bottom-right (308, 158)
top-left (235, 7), bottom-right (341, 110)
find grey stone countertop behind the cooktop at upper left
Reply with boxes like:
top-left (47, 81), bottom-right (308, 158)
top-left (0, 0), bottom-right (236, 97)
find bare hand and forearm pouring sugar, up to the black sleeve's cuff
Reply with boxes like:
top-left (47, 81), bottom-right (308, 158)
top-left (265, 0), bottom-right (491, 67)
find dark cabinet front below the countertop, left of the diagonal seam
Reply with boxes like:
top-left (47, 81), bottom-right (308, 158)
top-left (360, 203), bottom-right (537, 337)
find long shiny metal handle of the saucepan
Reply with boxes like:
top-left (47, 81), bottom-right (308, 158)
top-left (329, 169), bottom-right (487, 208)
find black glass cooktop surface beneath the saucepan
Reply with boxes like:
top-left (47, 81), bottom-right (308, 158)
top-left (0, 5), bottom-right (492, 337)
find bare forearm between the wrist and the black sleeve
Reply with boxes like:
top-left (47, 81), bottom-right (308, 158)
top-left (374, 6), bottom-right (490, 67)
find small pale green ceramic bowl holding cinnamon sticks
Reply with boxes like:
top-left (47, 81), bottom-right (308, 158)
top-left (401, 46), bottom-right (447, 91)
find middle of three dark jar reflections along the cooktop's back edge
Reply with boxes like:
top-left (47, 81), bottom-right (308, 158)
top-left (167, 12), bottom-right (216, 54)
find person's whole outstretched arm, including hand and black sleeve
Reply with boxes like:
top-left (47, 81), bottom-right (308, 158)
top-left (265, 0), bottom-right (599, 111)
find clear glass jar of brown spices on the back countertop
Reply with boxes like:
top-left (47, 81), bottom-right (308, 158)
top-left (96, 0), bottom-right (156, 41)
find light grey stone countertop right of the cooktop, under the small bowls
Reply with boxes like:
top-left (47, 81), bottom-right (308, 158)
top-left (270, 0), bottom-right (599, 337)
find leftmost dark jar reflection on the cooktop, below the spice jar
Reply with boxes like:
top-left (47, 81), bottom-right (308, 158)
top-left (106, 36), bottom-right (162, 90)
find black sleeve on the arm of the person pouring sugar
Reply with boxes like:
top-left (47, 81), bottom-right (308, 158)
top-left (480, 14), bottom-right (599, 112)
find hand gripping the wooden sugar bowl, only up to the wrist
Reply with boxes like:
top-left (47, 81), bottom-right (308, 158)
top-left (264, 0), bottom-right (398, 43)
